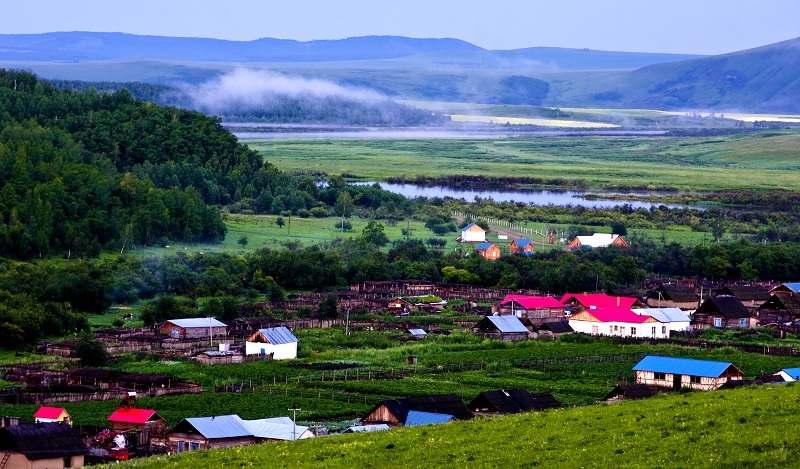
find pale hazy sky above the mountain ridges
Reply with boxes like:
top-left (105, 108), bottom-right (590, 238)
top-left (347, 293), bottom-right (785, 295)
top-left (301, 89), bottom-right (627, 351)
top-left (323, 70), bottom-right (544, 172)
top-left (6, 0), bottom-right (800, 54)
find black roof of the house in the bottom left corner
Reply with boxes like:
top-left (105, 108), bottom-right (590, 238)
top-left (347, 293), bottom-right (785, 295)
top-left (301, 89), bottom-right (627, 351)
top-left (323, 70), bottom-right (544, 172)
top-left (0, 422), bottom-right (89, 461)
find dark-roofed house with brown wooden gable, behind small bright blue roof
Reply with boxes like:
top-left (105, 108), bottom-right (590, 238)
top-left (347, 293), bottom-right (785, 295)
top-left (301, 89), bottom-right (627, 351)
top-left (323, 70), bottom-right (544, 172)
top-left (362, 394), bottom-right (473, 427)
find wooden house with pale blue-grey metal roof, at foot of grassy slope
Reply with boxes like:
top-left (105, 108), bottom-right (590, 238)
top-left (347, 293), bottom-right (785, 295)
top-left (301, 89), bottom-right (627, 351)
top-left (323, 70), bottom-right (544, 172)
top-left (166, 415), bottom-right (255, 453)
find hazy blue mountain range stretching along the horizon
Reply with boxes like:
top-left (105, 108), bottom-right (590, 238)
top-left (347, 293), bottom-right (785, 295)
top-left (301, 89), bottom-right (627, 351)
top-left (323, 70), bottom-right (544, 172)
top-left (0, 32), bottom-right (800, 114)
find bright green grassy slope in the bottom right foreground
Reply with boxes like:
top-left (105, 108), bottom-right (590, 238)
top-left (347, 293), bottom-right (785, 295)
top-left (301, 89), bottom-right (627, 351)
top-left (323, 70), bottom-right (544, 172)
top-left (120, 385), bottom-right (800, 468)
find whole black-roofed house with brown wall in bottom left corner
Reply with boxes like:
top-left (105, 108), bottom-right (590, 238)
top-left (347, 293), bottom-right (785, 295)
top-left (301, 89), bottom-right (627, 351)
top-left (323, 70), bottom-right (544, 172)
top-left (0, 422), bottom-right (89, 469)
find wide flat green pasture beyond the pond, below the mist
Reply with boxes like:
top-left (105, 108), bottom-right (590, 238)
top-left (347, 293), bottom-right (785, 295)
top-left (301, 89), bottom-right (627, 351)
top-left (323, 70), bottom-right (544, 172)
top-left (247, 131), bottom-right (800, 191)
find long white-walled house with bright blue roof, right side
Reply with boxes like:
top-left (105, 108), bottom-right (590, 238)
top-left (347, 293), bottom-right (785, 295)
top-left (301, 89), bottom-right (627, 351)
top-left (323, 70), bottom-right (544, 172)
top-left (633, 355), bottom-right (743, 391)
